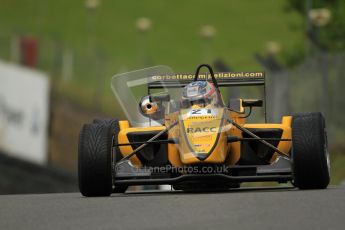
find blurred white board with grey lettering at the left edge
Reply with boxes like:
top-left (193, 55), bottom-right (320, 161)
top-left (0, 61), bottom-right (50, 164)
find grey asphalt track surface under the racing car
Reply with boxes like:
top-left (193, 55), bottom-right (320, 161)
top-left (0, 186), bottom-right (345, 230)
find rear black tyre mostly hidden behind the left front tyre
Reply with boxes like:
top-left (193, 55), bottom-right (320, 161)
top-left (93, 118), bottom-right (128, 193)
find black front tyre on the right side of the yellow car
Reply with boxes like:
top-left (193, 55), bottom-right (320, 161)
top-left (292, 113), bottom-right (330, 189)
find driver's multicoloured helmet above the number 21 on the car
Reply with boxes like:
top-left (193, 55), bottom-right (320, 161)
top-left (182, 81), bottom-right (219, 107)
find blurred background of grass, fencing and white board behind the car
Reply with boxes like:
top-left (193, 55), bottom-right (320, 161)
top-left (0, 0), bottom-right (345, 194)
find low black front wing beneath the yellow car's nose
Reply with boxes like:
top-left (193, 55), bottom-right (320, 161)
top-left (113, 157), bottom-right (293, 187)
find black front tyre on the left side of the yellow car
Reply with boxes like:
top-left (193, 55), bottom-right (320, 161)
top-left (78, 124), bottom-right (112, 196)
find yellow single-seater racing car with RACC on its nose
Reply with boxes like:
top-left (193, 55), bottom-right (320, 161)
top-left (78, 64), bottom-right (330, 197)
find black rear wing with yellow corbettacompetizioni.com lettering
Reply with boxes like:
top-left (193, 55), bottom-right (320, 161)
top-left (148, 72), bottom-right (265, 90)
